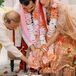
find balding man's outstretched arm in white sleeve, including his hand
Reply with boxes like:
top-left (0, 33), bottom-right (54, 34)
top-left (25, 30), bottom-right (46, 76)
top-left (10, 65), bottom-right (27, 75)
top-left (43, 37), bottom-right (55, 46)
top-left (0, 25), bottom-right (26, 62)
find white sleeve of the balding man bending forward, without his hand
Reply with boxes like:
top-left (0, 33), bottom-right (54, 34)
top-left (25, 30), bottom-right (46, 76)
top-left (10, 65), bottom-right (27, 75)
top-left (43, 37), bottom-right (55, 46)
top-left (0, 8), bottom-right (22, 57)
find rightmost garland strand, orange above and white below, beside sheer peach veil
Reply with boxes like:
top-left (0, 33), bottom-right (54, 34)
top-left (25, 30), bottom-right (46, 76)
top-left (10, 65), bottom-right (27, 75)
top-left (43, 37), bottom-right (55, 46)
top-left (47, 2), bottom-right (58, 38)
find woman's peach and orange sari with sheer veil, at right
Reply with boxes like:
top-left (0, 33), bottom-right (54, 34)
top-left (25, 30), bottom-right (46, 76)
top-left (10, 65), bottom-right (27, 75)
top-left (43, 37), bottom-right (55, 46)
top-left (43, 4), bottom-right (76, 72)
